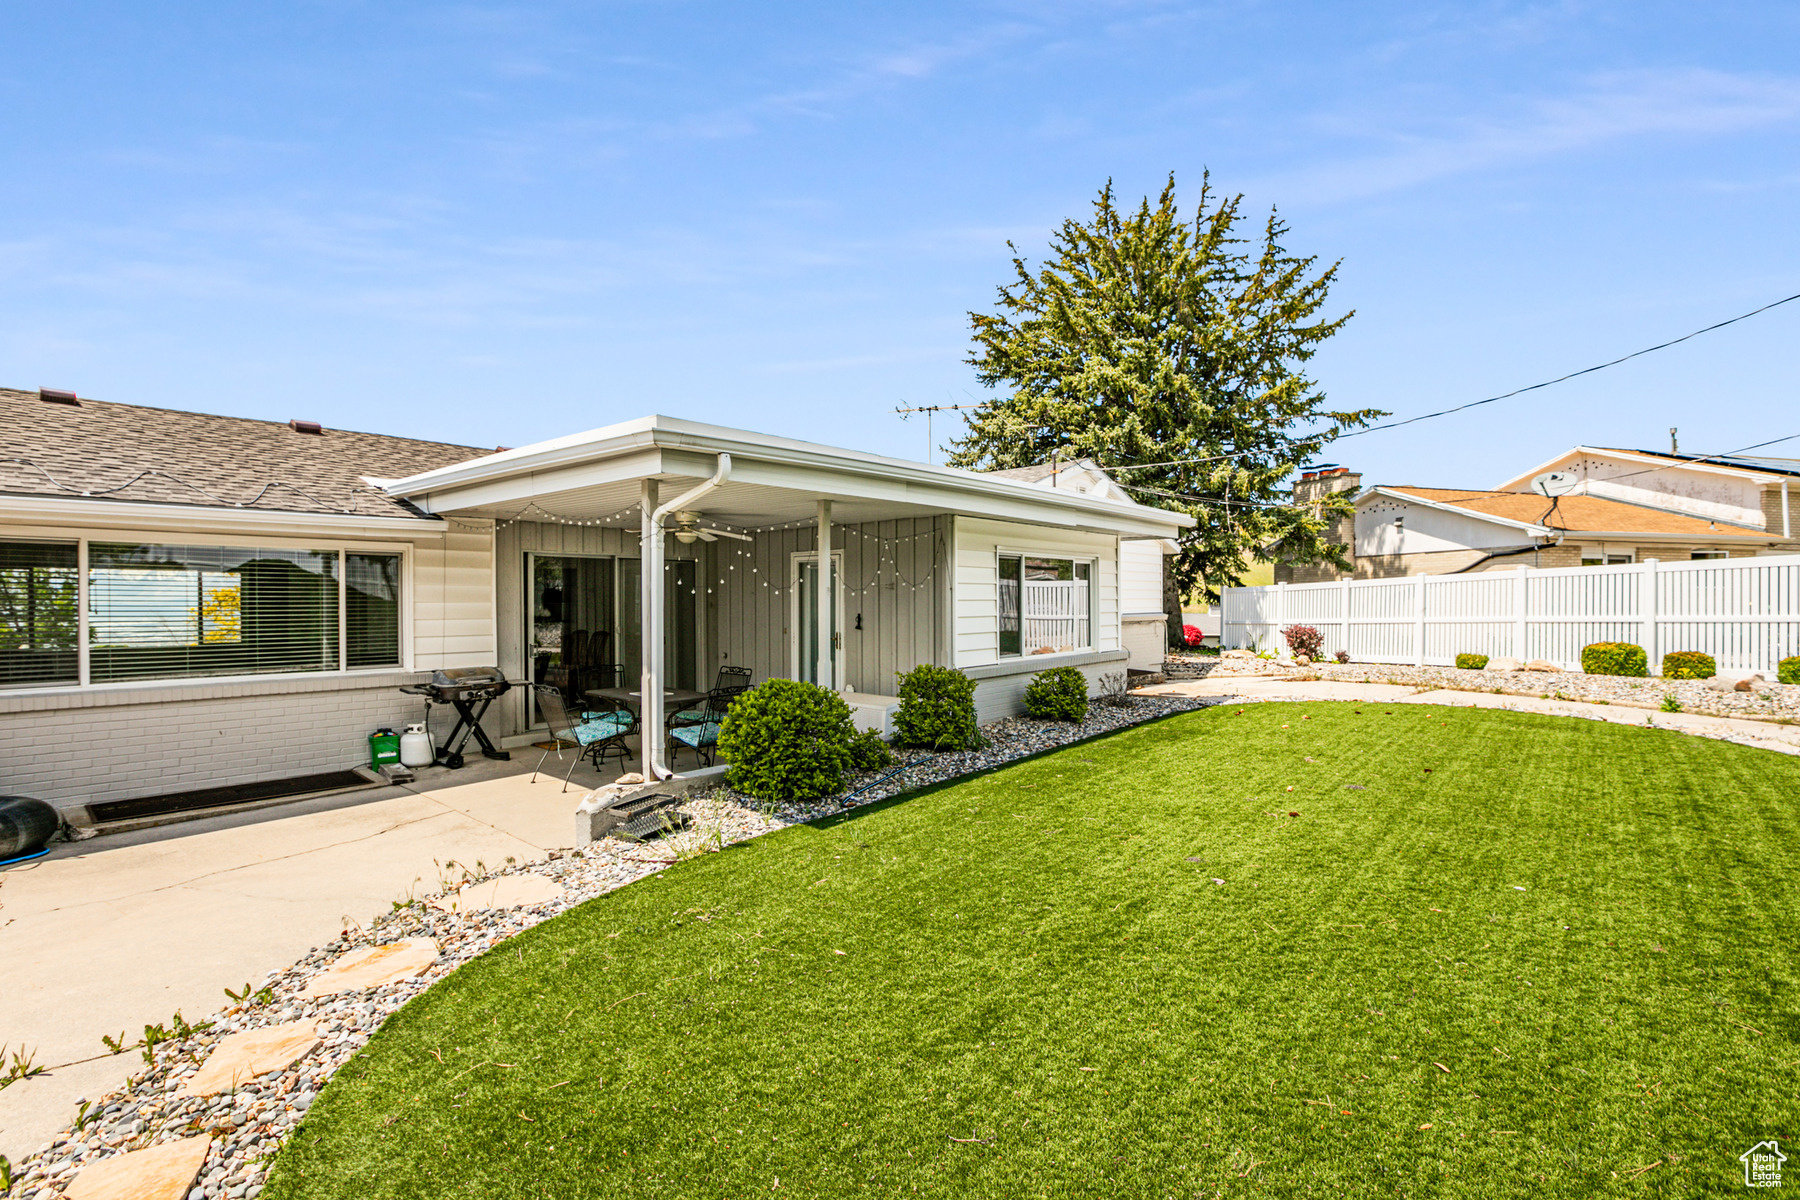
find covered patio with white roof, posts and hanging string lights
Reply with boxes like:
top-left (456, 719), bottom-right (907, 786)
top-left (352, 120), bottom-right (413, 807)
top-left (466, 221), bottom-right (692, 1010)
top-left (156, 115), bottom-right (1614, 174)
top-left (383, 416), bottom-right (1186, 777)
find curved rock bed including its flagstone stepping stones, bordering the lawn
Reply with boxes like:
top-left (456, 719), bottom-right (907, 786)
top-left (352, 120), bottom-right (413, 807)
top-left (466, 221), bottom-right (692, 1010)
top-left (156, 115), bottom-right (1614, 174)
top-left (4, 696), bottom-right (1220, 1200)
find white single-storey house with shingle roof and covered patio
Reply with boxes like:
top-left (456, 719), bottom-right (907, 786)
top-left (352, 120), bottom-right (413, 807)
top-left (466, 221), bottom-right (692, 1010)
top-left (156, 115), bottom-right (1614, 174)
top-left (0, 390), bottom-right (1192, 820)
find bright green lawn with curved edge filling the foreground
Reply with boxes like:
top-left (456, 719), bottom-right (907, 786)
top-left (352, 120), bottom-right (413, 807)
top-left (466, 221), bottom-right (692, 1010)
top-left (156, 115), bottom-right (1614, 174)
top-left (265, 703), bottom-right (1800, 1200)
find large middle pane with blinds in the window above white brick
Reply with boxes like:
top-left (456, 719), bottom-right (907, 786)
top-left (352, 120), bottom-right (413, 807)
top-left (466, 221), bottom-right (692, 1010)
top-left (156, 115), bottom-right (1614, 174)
top-left (88, 542), bottom-right (338, 684)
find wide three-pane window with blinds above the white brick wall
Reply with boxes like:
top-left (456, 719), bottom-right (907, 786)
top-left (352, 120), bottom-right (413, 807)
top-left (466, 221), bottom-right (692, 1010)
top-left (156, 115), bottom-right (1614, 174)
top-left (0, 540), bottom-right (401, 685)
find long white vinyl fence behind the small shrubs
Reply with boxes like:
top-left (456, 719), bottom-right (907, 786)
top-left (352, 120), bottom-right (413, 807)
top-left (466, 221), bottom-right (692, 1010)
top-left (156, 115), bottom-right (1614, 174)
top-left (1220, 554), bottom-right (1800, 678)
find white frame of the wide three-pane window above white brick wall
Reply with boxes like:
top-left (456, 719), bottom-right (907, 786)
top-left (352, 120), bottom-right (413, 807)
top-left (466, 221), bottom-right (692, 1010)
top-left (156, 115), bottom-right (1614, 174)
top-left (0, 525), bottom-right (416, 696)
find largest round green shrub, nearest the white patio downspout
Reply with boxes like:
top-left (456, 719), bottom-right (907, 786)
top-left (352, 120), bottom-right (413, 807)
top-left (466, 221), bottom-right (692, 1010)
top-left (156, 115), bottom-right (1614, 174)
top-left (718, 680), bottom-right (857, 801)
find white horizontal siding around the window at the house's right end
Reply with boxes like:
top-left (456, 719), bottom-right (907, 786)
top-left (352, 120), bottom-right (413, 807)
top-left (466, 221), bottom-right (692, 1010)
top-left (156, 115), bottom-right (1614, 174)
top-left (952, 516), bottom-right (1120, 667)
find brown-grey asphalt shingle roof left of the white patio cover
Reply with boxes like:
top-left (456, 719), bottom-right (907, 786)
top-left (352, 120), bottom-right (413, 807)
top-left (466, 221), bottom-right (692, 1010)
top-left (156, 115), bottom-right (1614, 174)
top-left (0, 389), bottom-right (493, 516)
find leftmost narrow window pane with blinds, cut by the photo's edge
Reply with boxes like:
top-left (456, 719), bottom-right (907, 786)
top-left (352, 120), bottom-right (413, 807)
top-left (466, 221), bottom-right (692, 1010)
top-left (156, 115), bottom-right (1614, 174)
top-left (0, 542), bottom-right (81, 687)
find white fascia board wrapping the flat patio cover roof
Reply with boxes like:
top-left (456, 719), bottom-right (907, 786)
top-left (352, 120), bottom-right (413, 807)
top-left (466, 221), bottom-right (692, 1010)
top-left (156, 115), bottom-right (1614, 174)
top-left (389, 416), bottom-right (1195, 536)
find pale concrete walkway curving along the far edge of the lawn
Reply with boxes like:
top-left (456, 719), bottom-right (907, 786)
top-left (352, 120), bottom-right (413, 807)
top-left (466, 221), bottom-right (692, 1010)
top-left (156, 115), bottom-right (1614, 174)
top-left (1139, 675), bottom-right (1800, 754)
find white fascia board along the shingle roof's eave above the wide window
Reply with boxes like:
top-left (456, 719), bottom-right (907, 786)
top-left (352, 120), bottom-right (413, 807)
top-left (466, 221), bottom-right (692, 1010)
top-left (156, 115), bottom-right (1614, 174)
top-left (0, 497), bottom-right (445, 542)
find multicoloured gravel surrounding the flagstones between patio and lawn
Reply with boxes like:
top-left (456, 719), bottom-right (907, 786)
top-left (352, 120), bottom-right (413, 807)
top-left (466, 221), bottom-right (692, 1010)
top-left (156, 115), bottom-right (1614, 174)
top-left (0, 696), bottom-right (1228, 1200)
